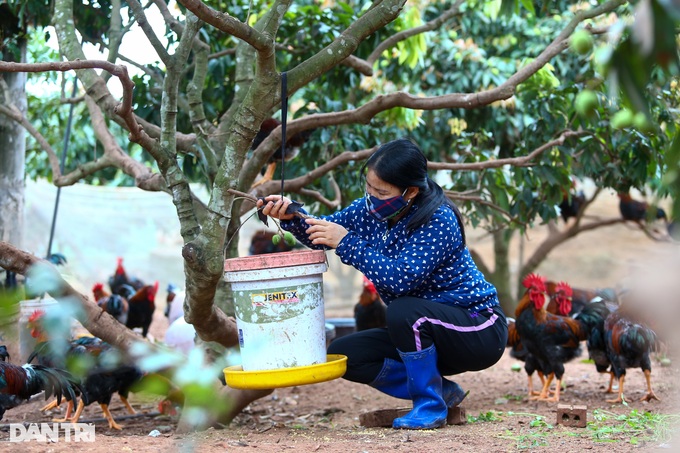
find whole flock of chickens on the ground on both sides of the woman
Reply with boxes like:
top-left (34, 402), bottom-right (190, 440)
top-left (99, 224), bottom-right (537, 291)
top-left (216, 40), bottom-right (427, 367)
top-left (0, 223), bottom-right (660, 429)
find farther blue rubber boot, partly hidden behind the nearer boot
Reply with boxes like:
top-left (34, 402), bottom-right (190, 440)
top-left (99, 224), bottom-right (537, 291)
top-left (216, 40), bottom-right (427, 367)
top-left (368, 359), bottom-right (467, 409)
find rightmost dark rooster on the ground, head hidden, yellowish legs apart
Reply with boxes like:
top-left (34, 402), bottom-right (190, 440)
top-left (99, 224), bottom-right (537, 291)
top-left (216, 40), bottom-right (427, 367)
top-left (604, 306), bottom-right (659, 403)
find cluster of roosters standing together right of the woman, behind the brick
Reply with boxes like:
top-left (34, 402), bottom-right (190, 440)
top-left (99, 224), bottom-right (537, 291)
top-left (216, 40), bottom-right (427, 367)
top-left (508, 274), bottom-right (660, 403)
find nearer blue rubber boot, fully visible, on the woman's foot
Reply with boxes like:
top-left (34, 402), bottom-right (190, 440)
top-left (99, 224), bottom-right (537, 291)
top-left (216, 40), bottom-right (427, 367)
top-left (392, 345), bottom-right (448, 429)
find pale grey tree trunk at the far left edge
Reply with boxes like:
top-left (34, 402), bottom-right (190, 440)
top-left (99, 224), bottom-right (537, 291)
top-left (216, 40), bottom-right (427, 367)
top-left (0, 39), bottom-right (27, 247)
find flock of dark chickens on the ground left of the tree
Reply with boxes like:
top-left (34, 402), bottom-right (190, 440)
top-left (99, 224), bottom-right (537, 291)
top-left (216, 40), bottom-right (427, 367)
top-left (0, 258), bottom-right (184, 430)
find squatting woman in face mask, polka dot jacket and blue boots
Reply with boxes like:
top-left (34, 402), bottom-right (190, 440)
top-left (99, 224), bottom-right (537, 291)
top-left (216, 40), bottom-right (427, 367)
top-left (258, 139), bottom-right (507, 429)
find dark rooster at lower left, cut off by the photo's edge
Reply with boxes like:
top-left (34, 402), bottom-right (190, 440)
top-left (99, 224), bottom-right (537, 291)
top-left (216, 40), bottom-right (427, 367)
top-left (0, 361), bottom-right (82, 420)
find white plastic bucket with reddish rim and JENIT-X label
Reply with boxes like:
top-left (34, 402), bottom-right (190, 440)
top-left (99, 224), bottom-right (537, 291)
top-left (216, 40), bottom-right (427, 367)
top-left (224, 250), bottom-right (328, 371)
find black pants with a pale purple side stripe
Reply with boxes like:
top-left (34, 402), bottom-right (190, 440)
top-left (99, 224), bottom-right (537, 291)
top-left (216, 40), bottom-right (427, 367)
top-left (328, 297), bottom-right (508, 384)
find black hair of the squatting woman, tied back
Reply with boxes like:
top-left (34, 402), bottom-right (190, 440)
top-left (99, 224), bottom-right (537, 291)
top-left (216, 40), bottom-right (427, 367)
top-left (361, 138), bottom-right (465, 243)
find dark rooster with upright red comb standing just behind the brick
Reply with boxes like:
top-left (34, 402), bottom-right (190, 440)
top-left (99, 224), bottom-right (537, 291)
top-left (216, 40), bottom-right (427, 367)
top-left (515, 274), bottom-right (587, 402)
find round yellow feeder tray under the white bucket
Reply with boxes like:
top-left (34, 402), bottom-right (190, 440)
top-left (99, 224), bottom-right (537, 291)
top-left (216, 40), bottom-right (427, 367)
top-left (224, 354), bottom-right (347, 389)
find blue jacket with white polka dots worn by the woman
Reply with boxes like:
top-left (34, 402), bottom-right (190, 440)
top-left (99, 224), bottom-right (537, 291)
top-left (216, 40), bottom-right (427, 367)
top-left (281, 198), bottom-right (498, 313)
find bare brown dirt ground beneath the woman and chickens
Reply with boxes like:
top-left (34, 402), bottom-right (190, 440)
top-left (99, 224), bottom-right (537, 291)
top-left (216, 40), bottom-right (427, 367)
top-left (0, 191), bottom-right (680, 453)
